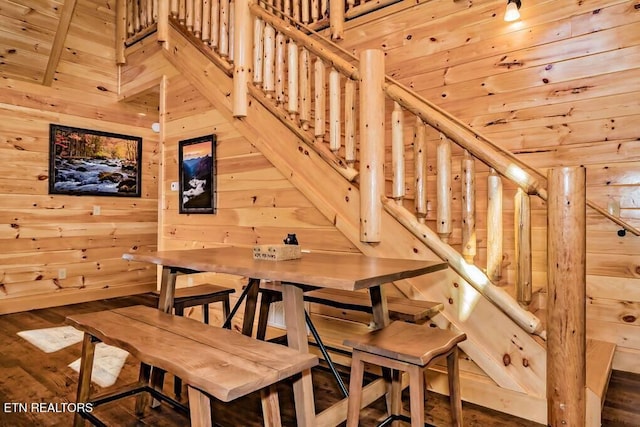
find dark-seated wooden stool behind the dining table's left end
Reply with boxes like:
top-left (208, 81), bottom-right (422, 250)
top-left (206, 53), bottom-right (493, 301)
top-left (152, 283), bottom-right (236, 398)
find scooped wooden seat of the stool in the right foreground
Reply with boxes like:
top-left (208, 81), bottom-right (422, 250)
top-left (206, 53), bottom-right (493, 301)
top-left (344, 321), bottom-right (467, 366)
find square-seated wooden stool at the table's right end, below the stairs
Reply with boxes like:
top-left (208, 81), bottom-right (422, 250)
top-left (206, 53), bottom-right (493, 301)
top-left (344, 321), bottom-right (467, 427)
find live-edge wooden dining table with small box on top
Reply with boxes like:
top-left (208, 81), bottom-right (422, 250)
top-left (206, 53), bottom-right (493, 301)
top-left (123, 247), bottom-right (447, 427)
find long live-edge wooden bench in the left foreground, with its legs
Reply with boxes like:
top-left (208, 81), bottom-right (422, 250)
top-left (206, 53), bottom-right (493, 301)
top-left (66, 306), bottom-right (318, 426)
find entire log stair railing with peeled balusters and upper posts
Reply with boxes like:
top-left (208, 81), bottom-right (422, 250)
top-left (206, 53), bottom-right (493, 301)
top-left (118, 0), bottom-right (640, 337)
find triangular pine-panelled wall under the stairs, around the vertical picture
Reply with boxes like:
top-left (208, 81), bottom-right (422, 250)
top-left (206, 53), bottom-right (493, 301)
top-left (160, 76), bottom-right (358, 270)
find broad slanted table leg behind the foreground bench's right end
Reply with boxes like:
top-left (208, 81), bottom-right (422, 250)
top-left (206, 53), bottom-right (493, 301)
top-left (282, 283), bottom-right (316, 427)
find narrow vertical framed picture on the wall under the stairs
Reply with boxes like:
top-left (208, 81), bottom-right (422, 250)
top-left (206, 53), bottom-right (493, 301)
top-left (178, 135), bottom-right (216, 214)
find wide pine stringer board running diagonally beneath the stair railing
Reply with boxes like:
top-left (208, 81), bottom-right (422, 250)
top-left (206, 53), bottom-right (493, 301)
top-left (158, 22), bottom-right (546, 397)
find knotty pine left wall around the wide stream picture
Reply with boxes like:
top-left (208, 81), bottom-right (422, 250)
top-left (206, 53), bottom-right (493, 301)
top-left (0, 74), bottom-right (159, 313)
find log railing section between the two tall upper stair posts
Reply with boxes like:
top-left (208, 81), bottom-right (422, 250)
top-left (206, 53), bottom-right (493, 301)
top-left (249, 4), bottom-right (358, 181)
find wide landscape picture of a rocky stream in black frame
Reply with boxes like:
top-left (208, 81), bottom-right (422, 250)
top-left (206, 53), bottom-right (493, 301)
top-left (49, 124), bottom-right (142, 197)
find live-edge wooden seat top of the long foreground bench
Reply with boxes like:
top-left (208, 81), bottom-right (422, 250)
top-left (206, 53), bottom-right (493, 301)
top-left (66, 306), bottom-right (318, 426)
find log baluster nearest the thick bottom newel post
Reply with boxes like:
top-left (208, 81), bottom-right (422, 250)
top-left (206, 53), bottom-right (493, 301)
top-left (514, 188), bottom-right (532, 308)
